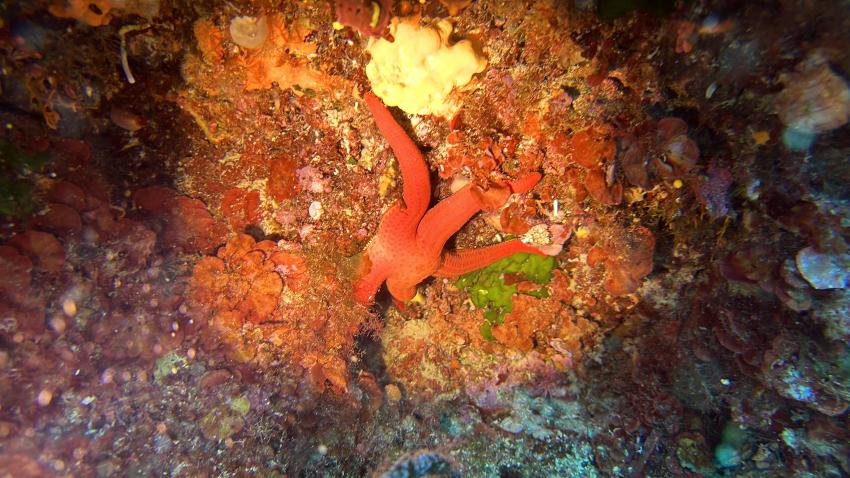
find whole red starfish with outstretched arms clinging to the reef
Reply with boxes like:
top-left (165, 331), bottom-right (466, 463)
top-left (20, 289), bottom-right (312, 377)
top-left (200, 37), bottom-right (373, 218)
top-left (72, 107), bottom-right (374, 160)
top-left (354, 93), bottom-right (542, 304)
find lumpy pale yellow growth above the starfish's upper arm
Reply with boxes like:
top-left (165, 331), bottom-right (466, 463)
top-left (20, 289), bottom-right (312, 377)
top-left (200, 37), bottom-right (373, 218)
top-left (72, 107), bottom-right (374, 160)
top-left (366, 18), bottom-right (487, 117)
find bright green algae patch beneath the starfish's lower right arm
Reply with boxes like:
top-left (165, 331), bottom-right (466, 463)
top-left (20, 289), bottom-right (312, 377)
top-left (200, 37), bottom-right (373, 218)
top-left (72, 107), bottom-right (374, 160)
top-left (455, 252), bottom-right (555, 340)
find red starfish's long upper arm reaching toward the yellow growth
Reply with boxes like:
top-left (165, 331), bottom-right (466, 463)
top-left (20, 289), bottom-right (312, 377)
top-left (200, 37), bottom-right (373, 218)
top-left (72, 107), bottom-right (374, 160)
top-left (365, 92), bottom-right (431, 221)
